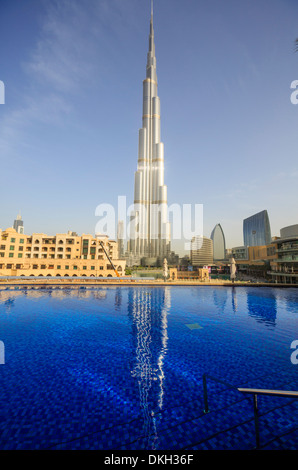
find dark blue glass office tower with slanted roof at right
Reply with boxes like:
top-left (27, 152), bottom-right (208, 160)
top-left (243, 210), bottom-right (271, 246)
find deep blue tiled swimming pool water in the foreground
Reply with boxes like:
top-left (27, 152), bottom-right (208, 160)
top-left (0, 286), bottom-right (298, 450)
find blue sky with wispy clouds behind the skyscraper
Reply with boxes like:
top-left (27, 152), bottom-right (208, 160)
top-left (0, 0), bottom-right (298, 255)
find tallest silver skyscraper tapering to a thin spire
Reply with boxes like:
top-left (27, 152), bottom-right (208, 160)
top-left (129, 6), bottom-right (170, 260)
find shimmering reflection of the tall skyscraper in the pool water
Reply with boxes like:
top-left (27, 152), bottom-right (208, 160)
top-left (129, 287), bottom-right (170, 449)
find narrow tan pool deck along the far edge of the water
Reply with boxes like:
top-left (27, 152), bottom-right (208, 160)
top-left (0, 277), bottom-right (298, 287)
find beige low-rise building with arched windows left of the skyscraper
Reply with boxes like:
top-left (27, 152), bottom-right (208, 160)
top-left (0, 228), bottom-right (126, 277)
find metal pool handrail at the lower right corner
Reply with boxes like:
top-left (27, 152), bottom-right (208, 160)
top-left (203, 374), bottom-right (298, 449)
